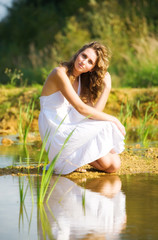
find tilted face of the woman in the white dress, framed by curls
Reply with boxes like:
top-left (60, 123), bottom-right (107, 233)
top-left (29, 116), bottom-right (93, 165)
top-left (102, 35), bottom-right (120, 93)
top-left (74, 48), bottom-right (97, 75)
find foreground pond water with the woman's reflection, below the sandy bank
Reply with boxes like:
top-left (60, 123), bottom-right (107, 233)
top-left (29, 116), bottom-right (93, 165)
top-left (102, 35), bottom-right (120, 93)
top-left (0, 174), bottom-right (158, 240)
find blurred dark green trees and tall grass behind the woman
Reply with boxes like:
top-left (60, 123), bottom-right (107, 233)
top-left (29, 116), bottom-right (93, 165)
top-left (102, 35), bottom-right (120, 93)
top-left (0, 0), bottom-right (158, 87)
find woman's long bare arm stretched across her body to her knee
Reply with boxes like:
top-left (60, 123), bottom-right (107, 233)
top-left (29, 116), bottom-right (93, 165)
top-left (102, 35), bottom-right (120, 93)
top-left (53, 67), bottom-right (125, 135)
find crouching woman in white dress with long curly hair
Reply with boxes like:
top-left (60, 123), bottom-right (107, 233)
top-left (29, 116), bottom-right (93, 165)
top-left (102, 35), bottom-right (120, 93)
top-left (39, 42), bottom-right (125, 174)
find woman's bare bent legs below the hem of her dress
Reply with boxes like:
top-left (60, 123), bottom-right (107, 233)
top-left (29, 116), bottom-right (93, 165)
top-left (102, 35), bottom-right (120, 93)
top-left (90, 150), bottom-right (121, 173)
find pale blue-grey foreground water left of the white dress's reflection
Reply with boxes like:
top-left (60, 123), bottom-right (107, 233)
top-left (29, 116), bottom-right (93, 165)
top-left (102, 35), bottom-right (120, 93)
top-left (0, 176), bottom-right (38, 240)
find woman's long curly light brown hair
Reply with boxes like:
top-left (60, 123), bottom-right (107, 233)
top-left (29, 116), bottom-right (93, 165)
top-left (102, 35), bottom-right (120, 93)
top-left (61, 41), bottom-right (111, 104)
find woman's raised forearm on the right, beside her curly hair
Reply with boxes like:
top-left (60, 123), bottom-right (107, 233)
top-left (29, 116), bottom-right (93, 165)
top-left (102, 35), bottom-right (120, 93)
top-left (93, 72), bottom-right (111, 112)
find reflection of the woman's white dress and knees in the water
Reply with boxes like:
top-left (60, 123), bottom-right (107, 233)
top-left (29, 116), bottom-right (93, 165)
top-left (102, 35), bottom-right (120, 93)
top-left (39, 176), bottom-right (126, 240)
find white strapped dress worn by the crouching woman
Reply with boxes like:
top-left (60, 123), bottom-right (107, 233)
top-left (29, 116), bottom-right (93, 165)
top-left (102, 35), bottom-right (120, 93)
top-left (38, 79), bottom-right (124, 174)
